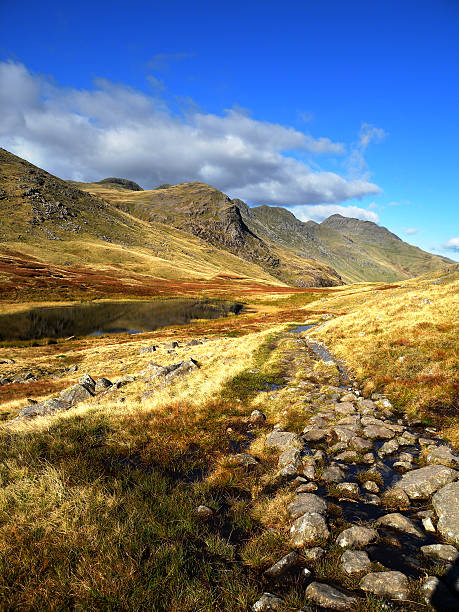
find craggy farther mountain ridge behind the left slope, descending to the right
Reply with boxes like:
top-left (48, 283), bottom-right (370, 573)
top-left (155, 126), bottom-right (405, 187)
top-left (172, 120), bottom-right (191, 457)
top-left (75, 179), bottom-right (452, 286)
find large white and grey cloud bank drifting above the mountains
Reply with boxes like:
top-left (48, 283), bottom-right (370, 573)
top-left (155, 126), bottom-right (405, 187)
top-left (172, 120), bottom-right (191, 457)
top-left (0, 57), bottom-right (380, 206)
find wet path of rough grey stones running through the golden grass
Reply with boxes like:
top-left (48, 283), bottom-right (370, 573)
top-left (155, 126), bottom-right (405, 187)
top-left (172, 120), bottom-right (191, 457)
top-left (246, 336), bottom-right (459, 612)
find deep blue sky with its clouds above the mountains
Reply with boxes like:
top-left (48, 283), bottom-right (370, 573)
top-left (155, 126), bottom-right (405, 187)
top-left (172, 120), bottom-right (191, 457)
top-left (0, 0), bottom-right (459, 260)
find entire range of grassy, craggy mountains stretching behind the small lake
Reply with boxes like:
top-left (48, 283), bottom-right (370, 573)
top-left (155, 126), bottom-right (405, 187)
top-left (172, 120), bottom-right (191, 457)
top-left (0, 149), bottom-right (451, 300)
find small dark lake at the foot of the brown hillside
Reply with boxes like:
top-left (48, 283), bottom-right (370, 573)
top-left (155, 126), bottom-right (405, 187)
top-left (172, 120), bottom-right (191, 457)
top-left (0, 298), bottom-right (242, 341)
